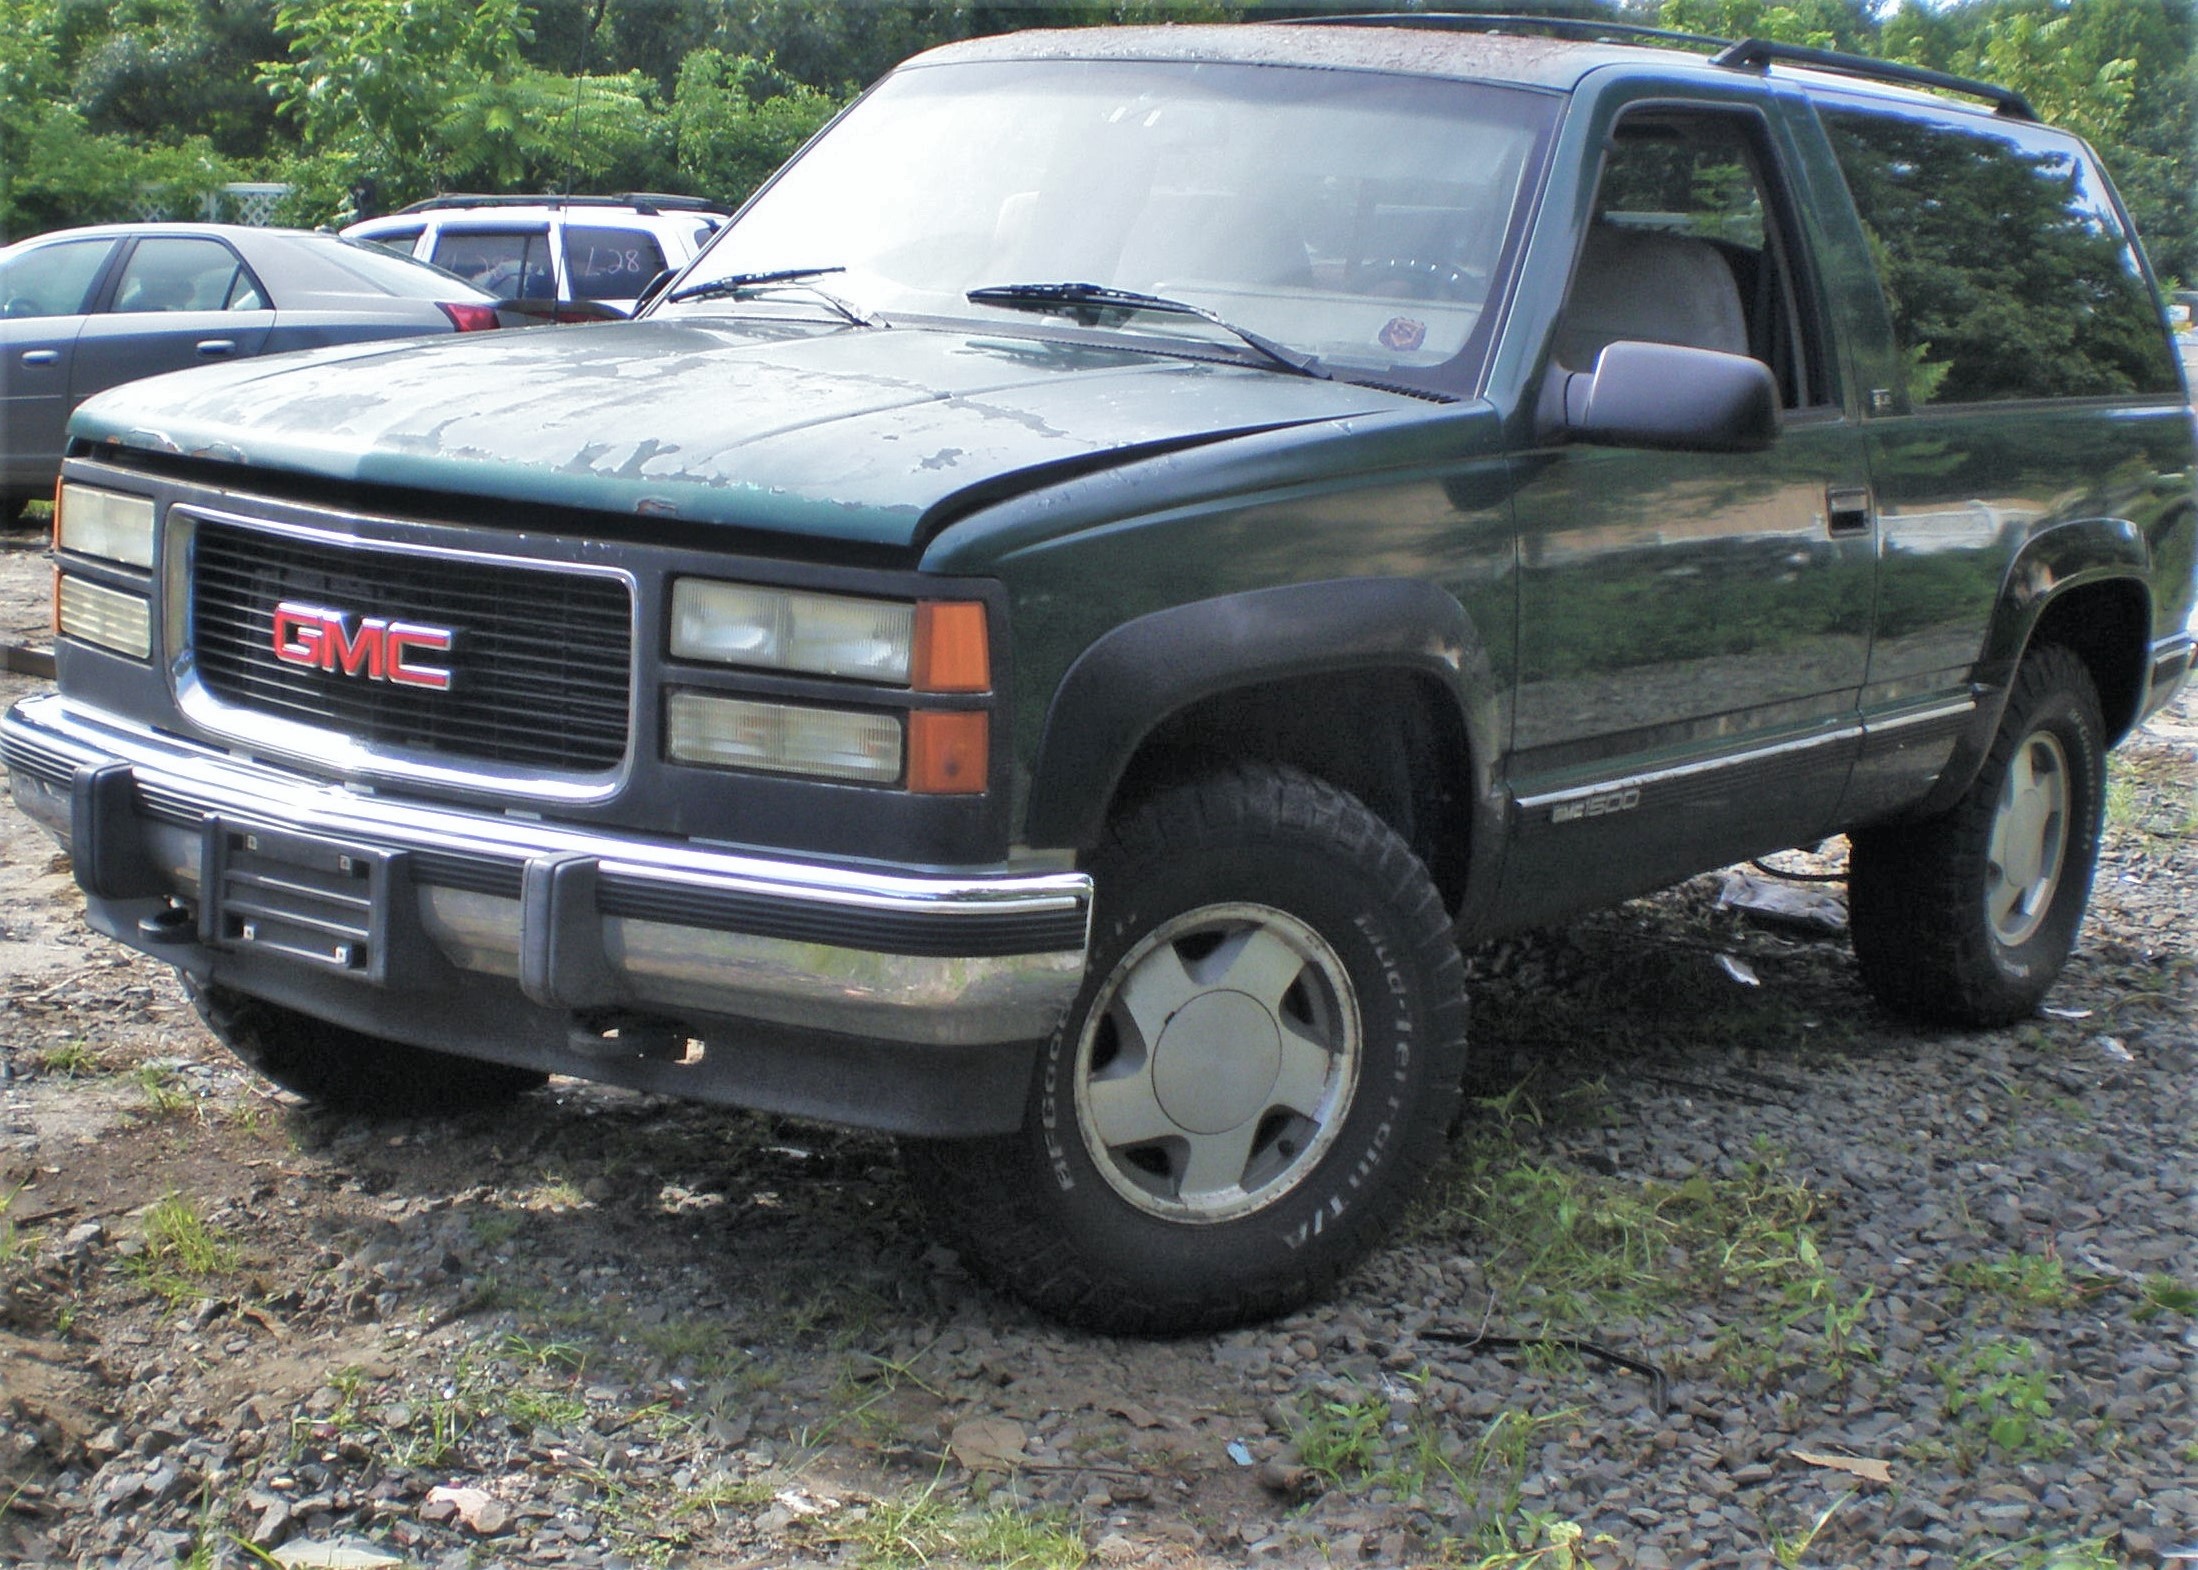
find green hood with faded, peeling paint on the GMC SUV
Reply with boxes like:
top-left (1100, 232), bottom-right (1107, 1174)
top-left (70, 317), bottom-right (1424, 548)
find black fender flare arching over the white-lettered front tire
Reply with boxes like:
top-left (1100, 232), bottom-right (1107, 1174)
top-left (1022, 578), bottom-right (1503, 906)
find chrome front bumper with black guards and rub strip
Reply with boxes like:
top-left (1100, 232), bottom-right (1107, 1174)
top-left (0, 695), bottom-right (1090, 1047)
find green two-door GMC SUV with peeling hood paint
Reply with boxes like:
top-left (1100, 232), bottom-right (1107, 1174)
top-left (0, 15), bottom-right (2198, 1330)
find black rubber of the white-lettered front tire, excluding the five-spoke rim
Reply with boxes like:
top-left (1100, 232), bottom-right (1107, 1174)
top-left (901, 763), bottom-right (1466, 1335)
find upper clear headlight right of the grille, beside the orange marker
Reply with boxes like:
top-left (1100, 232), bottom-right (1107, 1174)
top-left (673, 578), bottom-right (917, 686)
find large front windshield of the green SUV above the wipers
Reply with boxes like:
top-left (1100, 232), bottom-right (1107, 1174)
top-left (659, 59), bottom-right (1554, 389)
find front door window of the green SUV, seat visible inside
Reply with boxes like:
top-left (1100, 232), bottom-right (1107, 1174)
top-left (1556, 110), bottom-right (1831, 409)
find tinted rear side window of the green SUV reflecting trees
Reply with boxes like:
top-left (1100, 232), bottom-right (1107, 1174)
top-left (1820, 106), bottom-right (2178, 405)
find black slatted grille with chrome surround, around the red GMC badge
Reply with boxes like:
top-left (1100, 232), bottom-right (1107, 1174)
top-left (189, 521), bottom-right (633, 772)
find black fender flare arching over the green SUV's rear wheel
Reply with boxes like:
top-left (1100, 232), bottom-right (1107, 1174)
top-left (1903, 519), bottom-right (2152, 818)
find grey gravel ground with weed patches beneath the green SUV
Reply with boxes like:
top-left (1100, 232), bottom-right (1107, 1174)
top-left (0, 534), bottom-right (2198, 1570)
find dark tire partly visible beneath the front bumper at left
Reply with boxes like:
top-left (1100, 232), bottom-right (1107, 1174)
top-left (185, 979), bottom-right (550, 1115)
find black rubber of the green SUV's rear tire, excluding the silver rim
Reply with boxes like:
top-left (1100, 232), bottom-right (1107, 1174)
top-left (1846, 644), bottom-right (2106, 1027)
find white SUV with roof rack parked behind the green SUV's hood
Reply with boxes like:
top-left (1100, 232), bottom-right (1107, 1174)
top-left (343, 194), bottom-right (725, 321)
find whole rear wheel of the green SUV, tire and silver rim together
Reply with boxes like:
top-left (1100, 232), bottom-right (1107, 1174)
top-left (1846, 644), bottom-right (2106, 1025)
